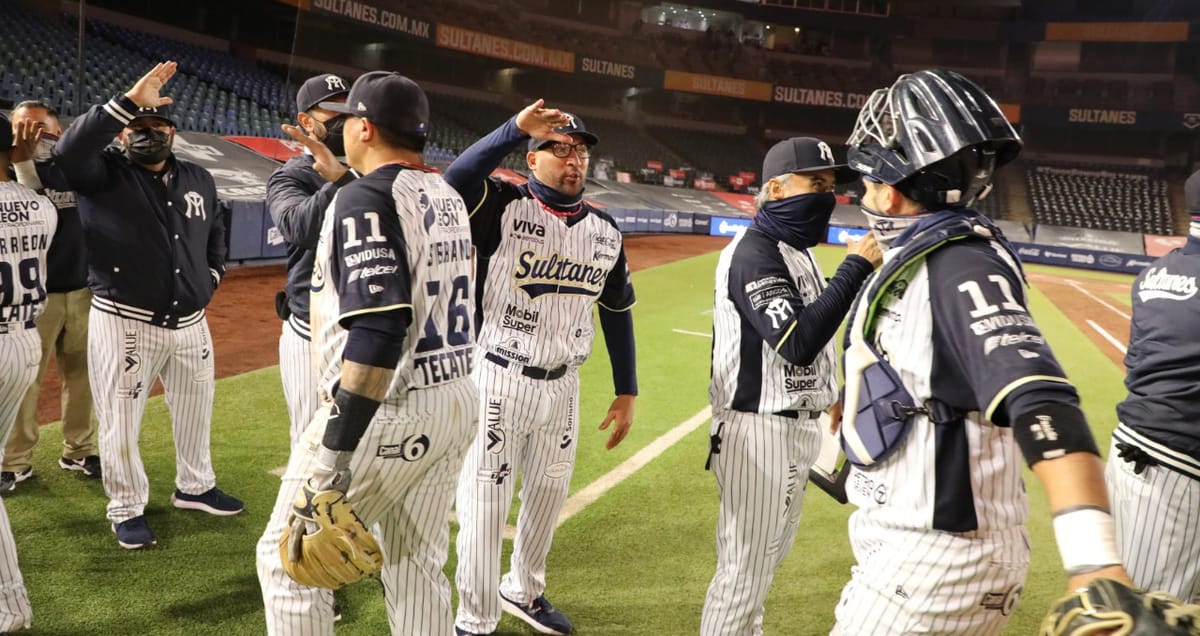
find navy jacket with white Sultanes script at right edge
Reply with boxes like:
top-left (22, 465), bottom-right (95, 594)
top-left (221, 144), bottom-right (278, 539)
top-left (1114, 236), bottom-right (1200, 468)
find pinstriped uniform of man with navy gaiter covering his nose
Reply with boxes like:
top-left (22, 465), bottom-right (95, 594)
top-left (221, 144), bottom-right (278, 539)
top-left (700, 226), bottom-right (854, 635)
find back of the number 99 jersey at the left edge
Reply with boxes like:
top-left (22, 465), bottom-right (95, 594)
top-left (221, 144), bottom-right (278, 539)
top-left (0, 181), bottom-right (58, 323)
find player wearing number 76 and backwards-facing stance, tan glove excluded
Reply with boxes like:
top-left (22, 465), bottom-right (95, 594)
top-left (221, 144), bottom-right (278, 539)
top-left (258, 71), bottom-right (478, 635)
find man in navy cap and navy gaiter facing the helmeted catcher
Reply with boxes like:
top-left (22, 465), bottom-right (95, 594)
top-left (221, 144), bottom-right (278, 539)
top-left (700, 137), bottom-right (881, 635)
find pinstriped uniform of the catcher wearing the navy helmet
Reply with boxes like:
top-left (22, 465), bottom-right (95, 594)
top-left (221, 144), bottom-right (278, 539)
top-left (833, 231), bottom-right (1069, 636)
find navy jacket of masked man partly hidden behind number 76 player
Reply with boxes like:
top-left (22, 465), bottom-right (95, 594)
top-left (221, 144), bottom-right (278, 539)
top-left (266, 154), bottom-right (354, 325)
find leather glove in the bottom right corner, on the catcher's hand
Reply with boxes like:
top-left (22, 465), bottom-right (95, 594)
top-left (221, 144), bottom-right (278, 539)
top-left (1038, 578), bottom-right (1200, 636)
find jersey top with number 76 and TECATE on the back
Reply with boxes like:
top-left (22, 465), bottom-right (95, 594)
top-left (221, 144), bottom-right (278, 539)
top-left (311, 166), bottom-right (474, 401)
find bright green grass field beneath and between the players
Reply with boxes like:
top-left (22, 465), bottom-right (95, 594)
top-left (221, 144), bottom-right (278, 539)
top-left (4, 247), bottom-right (1129, 636)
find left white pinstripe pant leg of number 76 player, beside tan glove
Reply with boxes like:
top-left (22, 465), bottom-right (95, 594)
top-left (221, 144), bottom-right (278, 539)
top-left (256, 407), bottom-right (334, 636)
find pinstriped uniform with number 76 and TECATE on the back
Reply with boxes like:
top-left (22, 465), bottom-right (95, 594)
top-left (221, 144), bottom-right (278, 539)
top-left (258, 164), bottom-right (478, 635)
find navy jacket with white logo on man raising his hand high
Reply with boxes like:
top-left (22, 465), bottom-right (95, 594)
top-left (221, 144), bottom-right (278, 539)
top-left (53, 96), bottom-right (226, 329)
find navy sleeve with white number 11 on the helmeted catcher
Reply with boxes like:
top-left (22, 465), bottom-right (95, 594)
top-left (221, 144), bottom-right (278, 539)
top-left (926, 241), bottom-right (1073, 421)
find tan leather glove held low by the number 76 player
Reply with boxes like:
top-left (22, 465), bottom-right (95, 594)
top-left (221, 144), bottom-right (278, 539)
top-left (280, 482), bottom-right (383, 589)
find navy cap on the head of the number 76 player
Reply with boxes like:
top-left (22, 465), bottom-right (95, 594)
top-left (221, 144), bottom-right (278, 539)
top-left (318, 71), bottom-right (430, 137)
